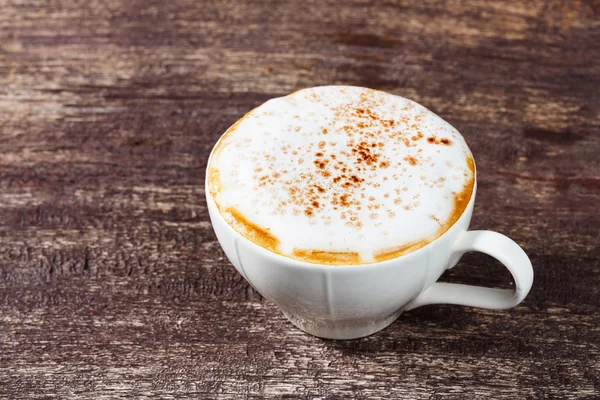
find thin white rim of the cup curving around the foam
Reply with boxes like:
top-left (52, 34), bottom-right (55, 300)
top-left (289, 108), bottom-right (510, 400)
top-left (204, 135), bottom-right (477, 271)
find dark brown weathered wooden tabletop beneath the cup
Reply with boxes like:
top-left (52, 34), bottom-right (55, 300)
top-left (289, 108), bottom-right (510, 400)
top-left (0, 0), bottom-right (600, 399)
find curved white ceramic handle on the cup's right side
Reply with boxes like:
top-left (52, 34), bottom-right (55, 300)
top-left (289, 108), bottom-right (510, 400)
top-left (405, 231), bottom-right (533, 311)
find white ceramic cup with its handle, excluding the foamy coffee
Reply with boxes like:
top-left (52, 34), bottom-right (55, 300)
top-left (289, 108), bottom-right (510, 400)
top-left (205, 156), bottom-right (533, 339)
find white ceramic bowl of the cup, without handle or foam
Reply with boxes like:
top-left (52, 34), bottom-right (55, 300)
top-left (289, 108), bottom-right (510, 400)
top-left (205, 170), bottom-right (477, 339)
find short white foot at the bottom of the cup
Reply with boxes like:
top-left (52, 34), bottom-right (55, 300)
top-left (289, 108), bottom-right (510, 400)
top-left (281, 310), bottom-right (402, 340)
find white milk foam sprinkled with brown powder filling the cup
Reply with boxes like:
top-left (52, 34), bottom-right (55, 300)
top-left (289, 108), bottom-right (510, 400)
top-left (209, 86), bottom-right (474, 263)
